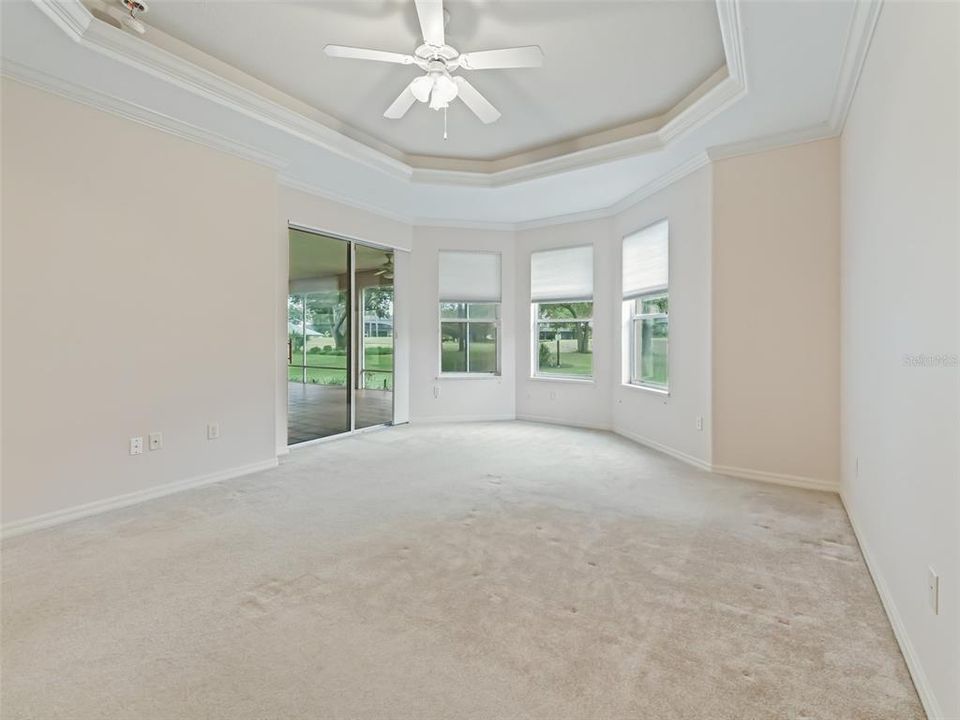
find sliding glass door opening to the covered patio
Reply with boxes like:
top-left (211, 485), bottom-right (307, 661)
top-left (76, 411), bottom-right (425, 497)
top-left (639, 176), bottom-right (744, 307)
top-left (287, 228), bottom-right (393, 445)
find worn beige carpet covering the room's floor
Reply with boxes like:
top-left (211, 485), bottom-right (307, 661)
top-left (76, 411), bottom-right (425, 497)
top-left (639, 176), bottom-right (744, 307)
top-left (2, 423), bottom-right (923, 720)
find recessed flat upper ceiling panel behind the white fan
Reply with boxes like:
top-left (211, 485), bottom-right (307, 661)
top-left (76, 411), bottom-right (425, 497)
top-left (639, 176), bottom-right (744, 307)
top-left (145, 0), bottom-right (724, 160)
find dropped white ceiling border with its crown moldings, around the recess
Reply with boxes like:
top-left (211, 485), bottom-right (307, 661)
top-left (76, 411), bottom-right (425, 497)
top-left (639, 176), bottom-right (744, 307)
top-left (0, 0), bottom-right (882, 228)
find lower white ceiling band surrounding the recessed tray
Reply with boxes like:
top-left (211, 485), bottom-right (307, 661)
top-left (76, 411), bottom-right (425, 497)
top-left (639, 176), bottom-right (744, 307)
top-left (0, 0), bottom-right (856, 227)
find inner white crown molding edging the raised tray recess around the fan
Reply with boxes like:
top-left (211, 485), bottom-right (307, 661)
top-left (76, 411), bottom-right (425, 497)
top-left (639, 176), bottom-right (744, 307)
top-left (33, 0), bottom-right (747, 188)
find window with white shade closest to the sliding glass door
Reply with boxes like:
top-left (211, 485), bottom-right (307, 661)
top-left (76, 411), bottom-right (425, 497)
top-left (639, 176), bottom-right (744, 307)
top-left (440, 251), bottom-right (500, 375)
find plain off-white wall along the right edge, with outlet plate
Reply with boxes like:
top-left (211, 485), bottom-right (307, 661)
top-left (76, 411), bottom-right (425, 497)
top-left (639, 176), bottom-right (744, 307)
top-left (842, 2), bottom-right (960, 718)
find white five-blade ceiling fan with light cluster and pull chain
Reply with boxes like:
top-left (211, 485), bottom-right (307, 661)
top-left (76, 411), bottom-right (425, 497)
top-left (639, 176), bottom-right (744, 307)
top-left (324, 0), bottom-right (543, 123)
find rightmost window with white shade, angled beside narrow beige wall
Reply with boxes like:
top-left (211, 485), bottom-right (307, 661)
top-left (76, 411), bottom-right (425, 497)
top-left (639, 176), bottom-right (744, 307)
top-left (623, 220), bottom-right (670, 390)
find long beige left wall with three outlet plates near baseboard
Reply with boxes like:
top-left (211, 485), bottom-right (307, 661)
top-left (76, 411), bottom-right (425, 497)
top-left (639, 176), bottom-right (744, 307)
top-left (2, 80), bottom-right (278, 523)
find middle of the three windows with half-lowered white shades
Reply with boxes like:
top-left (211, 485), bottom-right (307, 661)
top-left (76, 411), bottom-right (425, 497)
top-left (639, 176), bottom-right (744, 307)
top-left (530, 246), bottom-right (593, 380)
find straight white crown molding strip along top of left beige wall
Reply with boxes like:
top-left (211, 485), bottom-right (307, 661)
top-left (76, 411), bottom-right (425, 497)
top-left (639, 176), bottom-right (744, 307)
top-left (0, 58), bottom-right (287, 170)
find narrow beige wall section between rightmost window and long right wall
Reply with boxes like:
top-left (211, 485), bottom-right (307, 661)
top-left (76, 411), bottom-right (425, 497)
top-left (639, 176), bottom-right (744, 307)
top-left (712, 139), bottom-right (840, 486)
